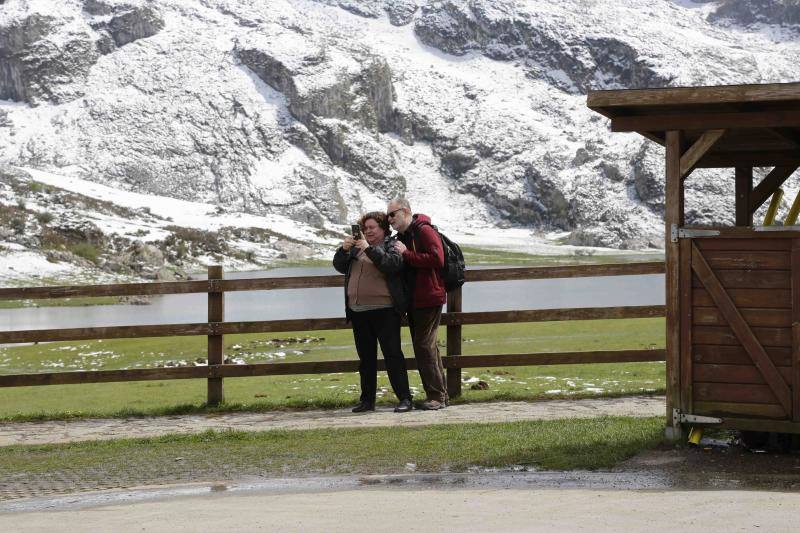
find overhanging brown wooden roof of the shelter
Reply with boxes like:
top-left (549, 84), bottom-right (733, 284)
top-left (587, 83), bottom-right (800, 167)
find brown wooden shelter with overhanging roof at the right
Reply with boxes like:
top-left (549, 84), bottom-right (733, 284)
top-left (587, 83), bottom-right (800, 438)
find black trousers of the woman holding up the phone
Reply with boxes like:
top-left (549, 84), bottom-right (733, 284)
top-left (350, 307), bottom-right (411, 403)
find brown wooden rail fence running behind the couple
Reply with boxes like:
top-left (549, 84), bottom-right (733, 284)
top-left (0, 262), bottom-right (666, 405)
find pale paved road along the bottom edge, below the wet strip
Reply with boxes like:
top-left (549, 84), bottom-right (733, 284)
top-left (0, 487), bottom-right (800, 533)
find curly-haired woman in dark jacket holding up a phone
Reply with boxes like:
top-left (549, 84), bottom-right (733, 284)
top-left (333, 211), bottom-right (412, 413)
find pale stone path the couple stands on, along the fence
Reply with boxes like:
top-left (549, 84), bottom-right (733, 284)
top-left (0, 396), bottom-right (665, 446)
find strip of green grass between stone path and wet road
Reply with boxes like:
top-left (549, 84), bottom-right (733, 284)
top-left (0, 415), bottom-right (664, 474)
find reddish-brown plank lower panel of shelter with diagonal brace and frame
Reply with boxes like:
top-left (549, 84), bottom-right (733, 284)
top-left (680, 232), bottom-right (800, 429)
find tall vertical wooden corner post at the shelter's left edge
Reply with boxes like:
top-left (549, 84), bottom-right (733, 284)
top-left (664, 131), bottom-right (684, 441)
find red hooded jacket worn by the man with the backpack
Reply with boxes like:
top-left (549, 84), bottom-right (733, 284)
top-left (398, 214), bottom-right (447, 309)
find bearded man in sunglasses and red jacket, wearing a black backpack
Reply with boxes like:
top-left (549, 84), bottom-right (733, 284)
top-left (386, 198), bottom-right (448, 410)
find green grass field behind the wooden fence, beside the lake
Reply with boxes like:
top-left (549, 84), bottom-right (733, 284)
top-left (0, 318), bottom-right (664, 420)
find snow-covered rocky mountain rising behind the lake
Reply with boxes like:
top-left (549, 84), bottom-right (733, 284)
top-left (0, 0), bottom-right (800, 280)
